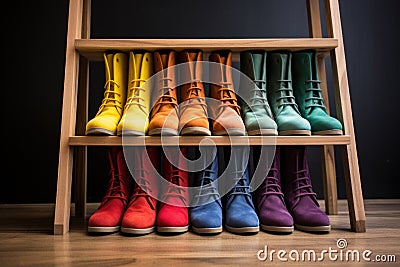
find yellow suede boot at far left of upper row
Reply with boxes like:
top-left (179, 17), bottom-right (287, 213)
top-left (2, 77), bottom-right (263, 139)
top-left (86, 53), bottom-right (128, 135)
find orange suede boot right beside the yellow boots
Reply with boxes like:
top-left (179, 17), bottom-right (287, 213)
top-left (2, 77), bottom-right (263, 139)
top-left (149, 50), bottom-right (179, 135)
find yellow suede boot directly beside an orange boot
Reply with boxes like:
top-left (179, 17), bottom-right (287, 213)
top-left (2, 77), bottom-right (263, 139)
top-left (117, 52), bottom-right (153, 135)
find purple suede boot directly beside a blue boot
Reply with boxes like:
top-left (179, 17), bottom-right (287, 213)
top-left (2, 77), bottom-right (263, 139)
top-left (255, 147), bottom-right (294, 233)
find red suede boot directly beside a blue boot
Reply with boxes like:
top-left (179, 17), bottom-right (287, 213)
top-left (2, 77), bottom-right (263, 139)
top-left (157, 147), bottom-right (189, 233)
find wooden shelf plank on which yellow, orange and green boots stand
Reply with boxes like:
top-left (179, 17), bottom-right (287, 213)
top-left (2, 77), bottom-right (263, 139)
top-left (69, 135), bottom-right (350, 146)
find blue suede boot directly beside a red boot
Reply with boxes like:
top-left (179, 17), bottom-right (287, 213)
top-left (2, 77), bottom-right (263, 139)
top-left (189, 155), bottom-right (222, 234)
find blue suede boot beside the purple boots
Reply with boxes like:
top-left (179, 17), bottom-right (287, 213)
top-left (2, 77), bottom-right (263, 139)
top-left (225, 155), bottom-right (259, 234)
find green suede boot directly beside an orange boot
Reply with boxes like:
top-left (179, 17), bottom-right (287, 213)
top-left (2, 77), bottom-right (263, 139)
top-left (239, 51), bottom-right (278, 135)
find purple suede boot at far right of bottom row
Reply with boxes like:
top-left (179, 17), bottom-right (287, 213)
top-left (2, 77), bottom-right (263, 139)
top-left (281, 146), bottom-right (331, 232)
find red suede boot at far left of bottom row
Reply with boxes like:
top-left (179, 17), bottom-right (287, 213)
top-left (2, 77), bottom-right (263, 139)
top-left (88, 147), bottom-right (132, 233)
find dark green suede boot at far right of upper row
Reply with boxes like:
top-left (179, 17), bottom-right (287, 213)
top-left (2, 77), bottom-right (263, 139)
top-left (292, 51), bottom-right (343, 135)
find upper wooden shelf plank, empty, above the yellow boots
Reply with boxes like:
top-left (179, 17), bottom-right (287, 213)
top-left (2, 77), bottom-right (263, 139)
top-left (75, 38), bottom-right (338, 61)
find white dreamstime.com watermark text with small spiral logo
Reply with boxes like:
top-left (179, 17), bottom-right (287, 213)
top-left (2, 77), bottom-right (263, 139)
top-left (257, 238), bottom-right (396, 262)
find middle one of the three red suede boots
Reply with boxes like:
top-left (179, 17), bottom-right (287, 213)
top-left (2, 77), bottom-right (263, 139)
top-left (121, 147), bottom-right (160, 235)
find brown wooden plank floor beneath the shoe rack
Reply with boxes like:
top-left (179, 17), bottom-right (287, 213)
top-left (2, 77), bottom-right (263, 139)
top-left (0, 200), bottom-right (400, 267)
